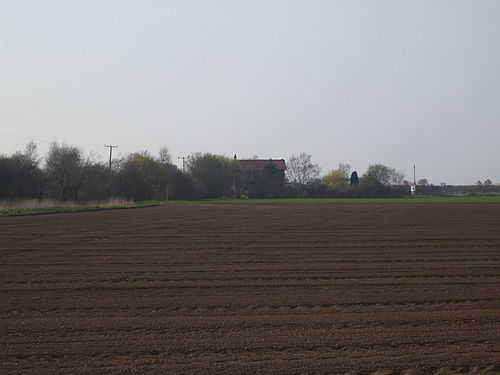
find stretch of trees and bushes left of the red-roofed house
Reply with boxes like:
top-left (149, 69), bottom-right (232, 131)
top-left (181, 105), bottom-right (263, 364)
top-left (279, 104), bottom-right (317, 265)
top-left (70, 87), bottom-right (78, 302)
top-left (0, 142), bottom-right (252, 203)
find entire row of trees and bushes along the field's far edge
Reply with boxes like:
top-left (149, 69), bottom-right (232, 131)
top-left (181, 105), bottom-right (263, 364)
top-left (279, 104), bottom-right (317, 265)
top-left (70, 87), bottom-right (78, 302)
top-left (0, 142), bottom-right (495, 203)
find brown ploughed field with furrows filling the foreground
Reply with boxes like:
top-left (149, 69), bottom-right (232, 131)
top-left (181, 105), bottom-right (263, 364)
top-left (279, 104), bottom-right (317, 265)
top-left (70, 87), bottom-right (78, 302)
top-left (0, 204), bottom-right (500, 375)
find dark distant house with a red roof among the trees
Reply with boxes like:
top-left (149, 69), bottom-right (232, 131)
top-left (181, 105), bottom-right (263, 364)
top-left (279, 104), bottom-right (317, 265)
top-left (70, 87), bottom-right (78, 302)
top-left (235, 155), bottom-right (286, 198)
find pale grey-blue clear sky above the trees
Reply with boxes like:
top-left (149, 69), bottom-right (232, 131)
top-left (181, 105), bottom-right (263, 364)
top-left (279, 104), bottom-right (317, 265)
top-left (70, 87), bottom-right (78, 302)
top-left (0, 0), bottom-right (500, 184)
